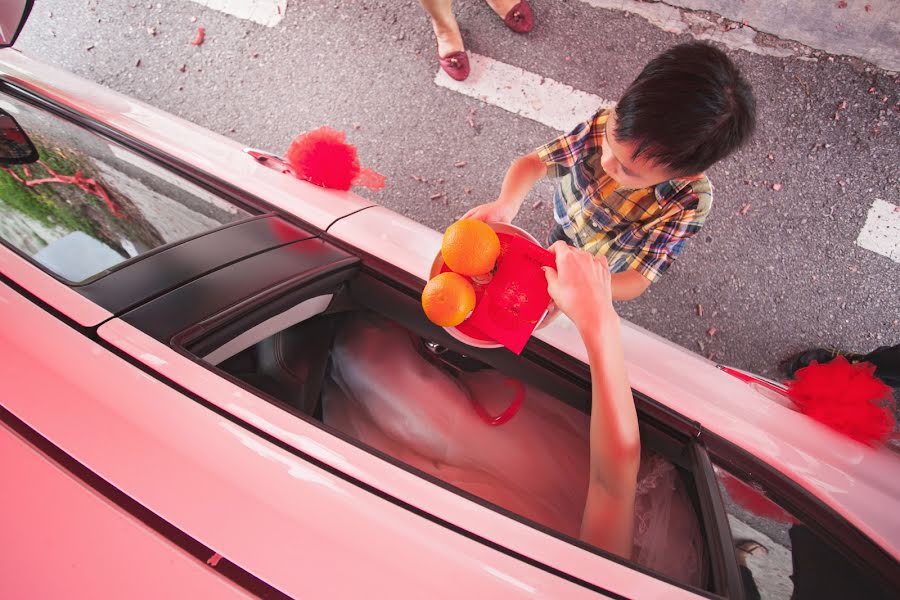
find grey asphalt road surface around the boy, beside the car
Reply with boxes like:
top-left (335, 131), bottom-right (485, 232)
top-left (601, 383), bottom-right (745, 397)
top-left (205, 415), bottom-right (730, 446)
top-left (17, 0), bottom-right (900, 375)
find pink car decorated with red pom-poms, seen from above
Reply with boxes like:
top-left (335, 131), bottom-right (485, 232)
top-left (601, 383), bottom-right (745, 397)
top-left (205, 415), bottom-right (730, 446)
top-left (0, 5), bottom-right (900, 599)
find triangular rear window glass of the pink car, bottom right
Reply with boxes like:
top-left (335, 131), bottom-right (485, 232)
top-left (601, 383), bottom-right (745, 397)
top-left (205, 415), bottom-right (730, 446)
top-left (714, 465), bottom-right (886, 600)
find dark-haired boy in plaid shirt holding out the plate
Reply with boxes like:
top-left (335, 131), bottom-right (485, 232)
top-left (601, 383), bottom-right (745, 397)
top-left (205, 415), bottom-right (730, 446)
top-left (464, 42), bottom-right (756, 300)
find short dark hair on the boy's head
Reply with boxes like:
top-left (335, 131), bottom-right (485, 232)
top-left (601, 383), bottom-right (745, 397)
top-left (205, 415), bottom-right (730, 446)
top-left (615, 42), bottom-right (756, 176)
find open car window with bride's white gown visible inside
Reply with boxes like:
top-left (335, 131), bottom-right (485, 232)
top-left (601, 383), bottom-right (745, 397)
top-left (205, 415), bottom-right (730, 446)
top-left (213, 302), bottom-right (710, 589)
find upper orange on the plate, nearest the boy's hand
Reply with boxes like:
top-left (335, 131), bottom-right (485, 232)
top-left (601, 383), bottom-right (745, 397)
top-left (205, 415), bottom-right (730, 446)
top-left (441, 219), bottom-right (500, 277)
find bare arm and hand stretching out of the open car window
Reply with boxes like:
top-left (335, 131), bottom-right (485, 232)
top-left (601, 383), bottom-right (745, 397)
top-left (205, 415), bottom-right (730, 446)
top-left (546, 242), bottom-right (641, 558)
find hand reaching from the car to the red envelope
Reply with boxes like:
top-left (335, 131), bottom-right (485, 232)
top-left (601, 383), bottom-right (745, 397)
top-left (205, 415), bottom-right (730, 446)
top-left (544, 241), bottom-right (615, 331)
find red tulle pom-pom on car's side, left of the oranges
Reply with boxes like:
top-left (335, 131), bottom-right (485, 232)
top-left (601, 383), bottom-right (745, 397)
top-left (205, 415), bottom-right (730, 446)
top-left (285, 127), bottom-right (384, 191)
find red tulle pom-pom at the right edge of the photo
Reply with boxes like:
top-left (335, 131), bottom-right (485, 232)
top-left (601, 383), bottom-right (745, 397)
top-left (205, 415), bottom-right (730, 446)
top-left (787, 356), bottom-right (894, 446)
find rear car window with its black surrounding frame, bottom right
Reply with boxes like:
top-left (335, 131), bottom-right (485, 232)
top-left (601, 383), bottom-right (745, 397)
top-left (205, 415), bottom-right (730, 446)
top-left (703, 433), bottom-right (900, 600)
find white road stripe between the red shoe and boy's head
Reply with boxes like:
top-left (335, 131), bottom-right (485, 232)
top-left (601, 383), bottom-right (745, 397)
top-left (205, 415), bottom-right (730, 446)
top-left (434, 53), bottom-right (613, 131)
